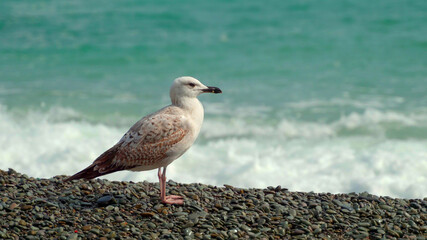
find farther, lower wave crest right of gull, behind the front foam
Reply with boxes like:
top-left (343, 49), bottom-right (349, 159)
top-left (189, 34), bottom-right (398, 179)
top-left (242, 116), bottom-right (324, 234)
top-left (202, 108), bottom-right (427, 139)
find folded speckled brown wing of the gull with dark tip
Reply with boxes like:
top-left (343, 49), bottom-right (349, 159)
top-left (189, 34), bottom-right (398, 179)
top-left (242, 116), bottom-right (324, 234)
top-left (67, 112), bottom-right (189, 180)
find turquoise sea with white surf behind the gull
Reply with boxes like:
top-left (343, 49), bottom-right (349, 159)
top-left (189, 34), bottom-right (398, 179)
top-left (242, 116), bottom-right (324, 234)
top-left (0, 0), bottom-right (427, 198)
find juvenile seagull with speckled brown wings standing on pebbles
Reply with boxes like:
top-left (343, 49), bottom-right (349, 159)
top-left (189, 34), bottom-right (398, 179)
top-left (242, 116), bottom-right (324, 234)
top-left (66, 77), bottom-right (222, 204)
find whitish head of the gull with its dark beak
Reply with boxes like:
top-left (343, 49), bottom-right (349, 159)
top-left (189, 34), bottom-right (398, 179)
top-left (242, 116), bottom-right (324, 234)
top-left (170, 77), bottom-right (222, 102)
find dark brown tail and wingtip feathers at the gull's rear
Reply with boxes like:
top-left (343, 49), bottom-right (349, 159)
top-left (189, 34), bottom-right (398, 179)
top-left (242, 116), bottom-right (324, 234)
top-left (65, 147), bottom-right (124, 181)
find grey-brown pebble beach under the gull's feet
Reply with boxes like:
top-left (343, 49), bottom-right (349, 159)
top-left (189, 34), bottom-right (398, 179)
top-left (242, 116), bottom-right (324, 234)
top-left (0, 169), bottom-right (427, 240)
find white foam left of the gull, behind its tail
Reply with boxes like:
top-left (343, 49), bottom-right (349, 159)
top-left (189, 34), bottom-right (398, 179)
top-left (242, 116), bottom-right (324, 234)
top-left (0, 104), bottom-right (123, 177)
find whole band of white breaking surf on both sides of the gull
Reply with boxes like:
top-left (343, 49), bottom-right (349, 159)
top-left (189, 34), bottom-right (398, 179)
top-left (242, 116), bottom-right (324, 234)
top-left (0, 105), bottom-right (427, 198)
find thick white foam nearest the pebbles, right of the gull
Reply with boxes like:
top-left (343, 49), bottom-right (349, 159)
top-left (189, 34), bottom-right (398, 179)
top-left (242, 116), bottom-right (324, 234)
top-left (169, 135), bottom-right (427, 198)
